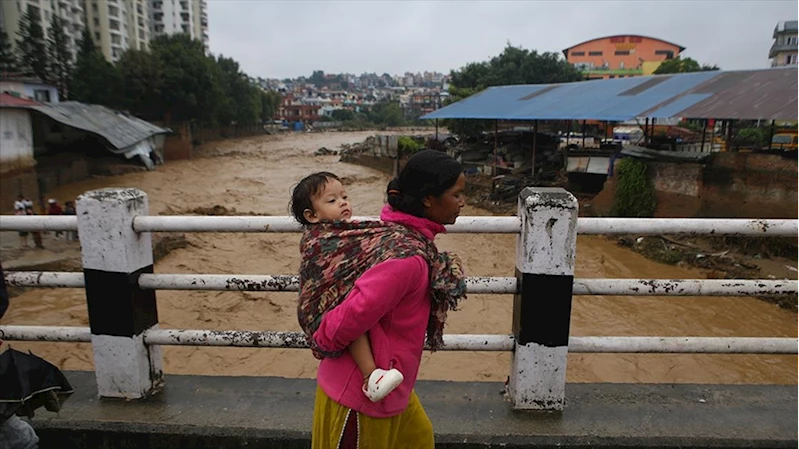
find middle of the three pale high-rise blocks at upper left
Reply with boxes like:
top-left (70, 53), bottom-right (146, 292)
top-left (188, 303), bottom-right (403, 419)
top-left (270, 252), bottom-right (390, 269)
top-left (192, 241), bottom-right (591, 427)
top-left (84, 0), bottom-right (150, 62)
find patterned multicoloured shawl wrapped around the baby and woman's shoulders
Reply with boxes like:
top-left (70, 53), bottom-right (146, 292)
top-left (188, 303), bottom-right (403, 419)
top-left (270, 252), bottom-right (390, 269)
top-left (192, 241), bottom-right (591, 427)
top-left (297, 221), bottom-right (466, 359)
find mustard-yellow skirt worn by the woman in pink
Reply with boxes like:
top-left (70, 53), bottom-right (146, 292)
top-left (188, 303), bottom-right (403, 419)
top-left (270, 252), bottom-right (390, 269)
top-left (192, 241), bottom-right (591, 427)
top-left (311, 385), bottom-right (435, 449)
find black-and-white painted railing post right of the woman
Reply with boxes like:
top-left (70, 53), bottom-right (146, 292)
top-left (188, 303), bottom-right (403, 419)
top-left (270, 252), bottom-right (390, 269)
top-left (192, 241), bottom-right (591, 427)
top-left (508, 187), bottom-right (578, 410)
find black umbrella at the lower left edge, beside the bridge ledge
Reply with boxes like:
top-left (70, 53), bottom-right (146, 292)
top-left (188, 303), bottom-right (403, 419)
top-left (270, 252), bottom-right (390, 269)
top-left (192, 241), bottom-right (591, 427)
top-left (0, 348), bottom-right (73, 422)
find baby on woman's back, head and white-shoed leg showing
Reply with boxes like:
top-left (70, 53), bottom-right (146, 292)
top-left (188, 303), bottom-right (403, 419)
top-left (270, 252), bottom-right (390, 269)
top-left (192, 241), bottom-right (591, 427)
top-left (291, 172), bottom-right (404, 402)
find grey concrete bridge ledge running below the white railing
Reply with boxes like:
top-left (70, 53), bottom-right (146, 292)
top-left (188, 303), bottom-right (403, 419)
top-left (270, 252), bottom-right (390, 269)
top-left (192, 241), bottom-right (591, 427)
top-left (32, 371), bottom-right (797, 449)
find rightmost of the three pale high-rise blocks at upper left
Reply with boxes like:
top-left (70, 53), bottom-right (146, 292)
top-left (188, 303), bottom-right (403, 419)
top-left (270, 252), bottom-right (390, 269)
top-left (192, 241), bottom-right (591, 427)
top-left (149, 0), bottom-right (208, 50)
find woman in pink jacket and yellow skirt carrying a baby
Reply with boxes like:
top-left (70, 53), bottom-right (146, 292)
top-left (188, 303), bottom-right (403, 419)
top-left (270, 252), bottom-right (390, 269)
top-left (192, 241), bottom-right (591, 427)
top-left (300, 150), bottom-right (466, 449)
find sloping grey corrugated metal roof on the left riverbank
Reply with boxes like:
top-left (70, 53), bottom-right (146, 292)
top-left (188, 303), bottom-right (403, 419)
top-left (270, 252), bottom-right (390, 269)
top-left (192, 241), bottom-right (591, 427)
top-left (29, 101), bottom-right (170, 150)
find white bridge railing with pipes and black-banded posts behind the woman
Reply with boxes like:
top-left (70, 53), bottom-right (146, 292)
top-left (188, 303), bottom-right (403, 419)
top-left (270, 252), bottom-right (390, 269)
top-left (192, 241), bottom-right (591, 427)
top-left (0, 188), bottom-right (798, 410)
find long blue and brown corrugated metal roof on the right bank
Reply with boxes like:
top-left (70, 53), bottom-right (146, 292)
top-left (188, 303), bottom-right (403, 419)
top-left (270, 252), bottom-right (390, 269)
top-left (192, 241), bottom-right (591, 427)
top-left (422, 67), bottom-right (798, 121)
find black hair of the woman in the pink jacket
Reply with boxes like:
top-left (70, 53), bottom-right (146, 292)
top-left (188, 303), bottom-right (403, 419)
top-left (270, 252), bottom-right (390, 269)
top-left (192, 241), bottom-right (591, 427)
top-left (386, 150), bottom-right (463, 217)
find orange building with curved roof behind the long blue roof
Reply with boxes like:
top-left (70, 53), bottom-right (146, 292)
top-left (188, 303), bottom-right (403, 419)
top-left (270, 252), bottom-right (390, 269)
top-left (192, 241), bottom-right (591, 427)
top-left (563, 34), bottom-right (685, 79)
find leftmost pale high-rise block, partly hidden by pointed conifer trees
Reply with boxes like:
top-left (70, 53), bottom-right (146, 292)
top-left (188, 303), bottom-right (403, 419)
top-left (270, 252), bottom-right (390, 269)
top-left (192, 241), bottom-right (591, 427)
top-left (0, 0), bottom-right (85, 61)
